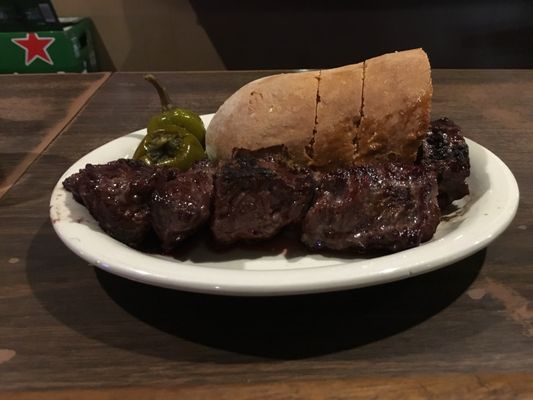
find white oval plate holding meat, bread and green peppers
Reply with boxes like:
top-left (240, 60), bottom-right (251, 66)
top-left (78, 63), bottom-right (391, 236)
top-left (50, 114), bottom-right (519, 296)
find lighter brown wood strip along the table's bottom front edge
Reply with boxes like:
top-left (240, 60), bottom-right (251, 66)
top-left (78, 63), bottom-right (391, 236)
top-left (3, 373), bottom-right (533, 400)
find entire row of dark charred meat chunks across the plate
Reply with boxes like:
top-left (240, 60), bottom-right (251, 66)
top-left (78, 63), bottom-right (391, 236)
top-left (63, 114), bottom-right (470, 253)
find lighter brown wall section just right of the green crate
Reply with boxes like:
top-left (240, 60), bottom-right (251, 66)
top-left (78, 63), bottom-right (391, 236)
top-left (53, 0), bottom-right (224, 71)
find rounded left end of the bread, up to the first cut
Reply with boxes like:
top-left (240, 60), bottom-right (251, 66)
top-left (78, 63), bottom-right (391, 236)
top-left (206, 71), bottom-right (319, 164)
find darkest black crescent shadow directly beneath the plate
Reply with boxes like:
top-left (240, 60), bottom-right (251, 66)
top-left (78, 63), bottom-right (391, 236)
top-left (97, 252), bottom-right (485, 359)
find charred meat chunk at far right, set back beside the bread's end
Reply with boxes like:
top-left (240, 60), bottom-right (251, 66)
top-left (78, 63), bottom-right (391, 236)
top-left (417, 118), bottom-right (470, 210)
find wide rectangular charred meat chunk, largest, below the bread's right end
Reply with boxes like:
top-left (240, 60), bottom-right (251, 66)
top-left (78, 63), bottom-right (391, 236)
top-left (302, 163), bottom-right (440, 253)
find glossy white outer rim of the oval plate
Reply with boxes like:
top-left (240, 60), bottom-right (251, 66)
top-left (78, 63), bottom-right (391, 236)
top-left (50, 114), bottom-right (519, 296)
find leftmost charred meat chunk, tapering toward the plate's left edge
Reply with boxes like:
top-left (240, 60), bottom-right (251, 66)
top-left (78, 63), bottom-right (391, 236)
top-left (63, 159), bottom-right (174, 247)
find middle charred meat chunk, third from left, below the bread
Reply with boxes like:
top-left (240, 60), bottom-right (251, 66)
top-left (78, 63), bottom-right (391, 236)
top-left (211, 146), bottom-right (314, 244)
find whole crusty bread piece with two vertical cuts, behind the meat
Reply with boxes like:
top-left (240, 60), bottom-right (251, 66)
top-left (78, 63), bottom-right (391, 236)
top-left (206, 49), bottom-right (432, 168)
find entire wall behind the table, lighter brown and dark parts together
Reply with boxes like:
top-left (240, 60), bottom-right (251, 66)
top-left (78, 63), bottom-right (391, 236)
top-left (54, 0), bottom-right (533, 71)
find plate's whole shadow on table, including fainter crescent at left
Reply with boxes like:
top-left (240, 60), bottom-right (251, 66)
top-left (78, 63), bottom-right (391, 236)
top-left (27, 223), bottom-right (485, 362)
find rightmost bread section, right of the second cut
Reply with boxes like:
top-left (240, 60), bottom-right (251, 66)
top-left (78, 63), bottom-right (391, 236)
top-left (354, 49), bottom-right (433, 164)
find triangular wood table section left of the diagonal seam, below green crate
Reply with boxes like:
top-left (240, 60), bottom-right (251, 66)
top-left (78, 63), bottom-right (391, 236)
top-left (0, 73), bottom-right (109, 197)
